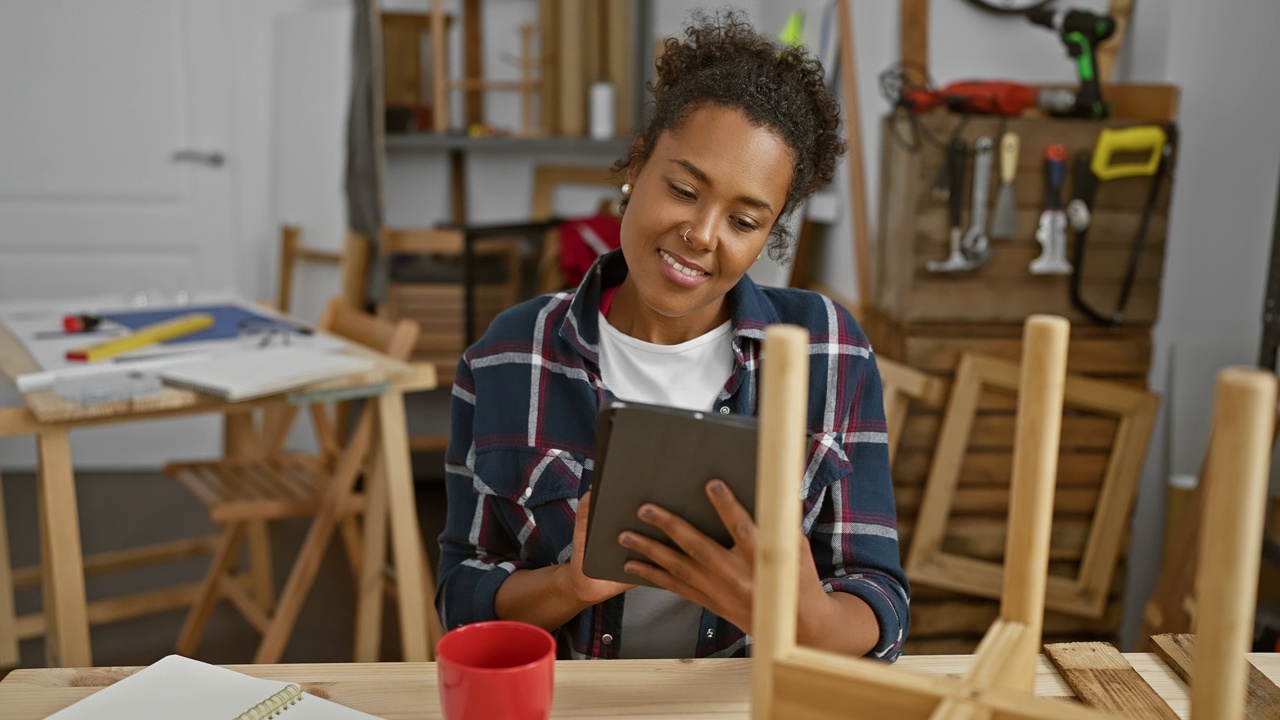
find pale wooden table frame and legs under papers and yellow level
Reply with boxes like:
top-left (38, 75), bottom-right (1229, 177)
top-left (0, 313), bottom-right (436, 666)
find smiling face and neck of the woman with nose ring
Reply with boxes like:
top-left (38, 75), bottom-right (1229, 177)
top-left (609, 105), bottom-right (794, 345)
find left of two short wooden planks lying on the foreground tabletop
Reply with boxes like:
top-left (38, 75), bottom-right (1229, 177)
top-left (1044, 643), bottom-right (1178, 720)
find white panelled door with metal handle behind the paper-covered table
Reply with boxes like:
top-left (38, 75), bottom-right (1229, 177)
top-left (0, 0), bottom-right (242, 468)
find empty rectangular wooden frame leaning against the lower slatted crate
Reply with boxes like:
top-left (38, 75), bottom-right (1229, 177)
top-left (905, 354), bottom-right (1160, 618)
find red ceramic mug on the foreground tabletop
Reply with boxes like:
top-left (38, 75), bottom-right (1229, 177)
top-left (435, 620), bottom-right (556, 720)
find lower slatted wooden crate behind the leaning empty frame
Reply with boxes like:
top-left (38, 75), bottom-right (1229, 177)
top-left (859, 307), bottom-right (1151, 653)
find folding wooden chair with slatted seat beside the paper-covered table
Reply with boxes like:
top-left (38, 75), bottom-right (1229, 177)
top-left (164, 297), bottom-right (430, 656)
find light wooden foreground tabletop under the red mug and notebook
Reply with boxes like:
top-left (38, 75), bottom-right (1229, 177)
top-left (0, 653), bottom-right (1280, 720)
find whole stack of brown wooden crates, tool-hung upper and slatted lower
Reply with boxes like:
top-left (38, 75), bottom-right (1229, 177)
top-left (859, 88), bottom-right (1176, 653)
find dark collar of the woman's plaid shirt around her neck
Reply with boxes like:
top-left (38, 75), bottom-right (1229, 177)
top-left (559, 250), bottom-right (781, 364)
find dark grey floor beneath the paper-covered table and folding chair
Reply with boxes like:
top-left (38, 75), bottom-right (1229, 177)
top-left (0, 462), bottom-right (444, 673)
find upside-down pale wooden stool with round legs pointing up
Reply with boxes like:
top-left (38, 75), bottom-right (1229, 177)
top-left (751, 316), bottom-right (1276, 720)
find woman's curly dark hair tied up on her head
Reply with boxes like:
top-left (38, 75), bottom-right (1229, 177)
top-left (613, 9), bottom-right (845, 260)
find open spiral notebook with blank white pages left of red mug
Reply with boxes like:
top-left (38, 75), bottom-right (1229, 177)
top-left (46, 655), bottom-right (379, 720)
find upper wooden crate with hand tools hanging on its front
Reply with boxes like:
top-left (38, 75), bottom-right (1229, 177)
top-left (869, 114), bottom-right (1175, 325)
